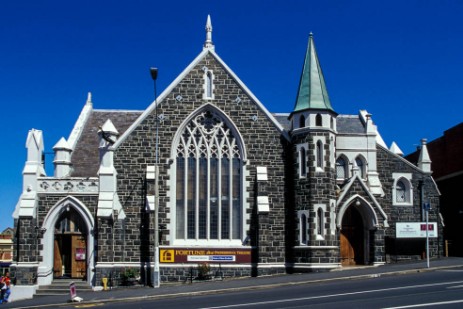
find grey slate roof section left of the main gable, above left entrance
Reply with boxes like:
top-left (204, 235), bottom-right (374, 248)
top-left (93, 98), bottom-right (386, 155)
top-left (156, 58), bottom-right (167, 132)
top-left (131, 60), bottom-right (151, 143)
top-left (71, 110), bottom-right (142, 177)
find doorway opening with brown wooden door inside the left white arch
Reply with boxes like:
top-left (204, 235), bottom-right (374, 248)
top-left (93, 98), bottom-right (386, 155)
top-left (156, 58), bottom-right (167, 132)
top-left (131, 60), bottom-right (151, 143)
top-left (53, 206), bottom-right (88, 279)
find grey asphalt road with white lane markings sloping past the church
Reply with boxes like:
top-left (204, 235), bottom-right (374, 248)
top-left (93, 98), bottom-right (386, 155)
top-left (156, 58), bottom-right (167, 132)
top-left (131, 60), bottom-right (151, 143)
top-left (40, 268), bottom-right (463, 309)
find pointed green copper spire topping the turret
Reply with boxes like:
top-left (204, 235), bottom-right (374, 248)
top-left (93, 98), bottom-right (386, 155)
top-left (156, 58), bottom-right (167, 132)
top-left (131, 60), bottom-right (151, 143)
top-left (294, 33), bottom-right (333, 112)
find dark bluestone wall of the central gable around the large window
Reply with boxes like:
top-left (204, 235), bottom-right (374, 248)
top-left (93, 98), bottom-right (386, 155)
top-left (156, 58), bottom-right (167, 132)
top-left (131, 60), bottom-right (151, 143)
top-left (110, 54), bottom-right (286, 279)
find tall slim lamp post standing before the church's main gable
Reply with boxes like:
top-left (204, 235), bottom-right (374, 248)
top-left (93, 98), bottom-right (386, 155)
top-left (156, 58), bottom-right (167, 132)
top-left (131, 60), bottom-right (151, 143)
top-left (150, 68), bottom-right (161, 288)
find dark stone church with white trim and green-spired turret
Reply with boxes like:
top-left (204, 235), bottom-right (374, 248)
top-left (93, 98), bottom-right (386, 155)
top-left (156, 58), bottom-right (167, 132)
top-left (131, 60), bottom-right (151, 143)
top-left (12, 17), bottom-right (442, 293)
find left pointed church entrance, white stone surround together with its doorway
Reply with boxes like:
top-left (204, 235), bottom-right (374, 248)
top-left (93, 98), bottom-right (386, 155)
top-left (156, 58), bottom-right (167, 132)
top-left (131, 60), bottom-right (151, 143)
top-left (37, 196), bottom-right (94, 285)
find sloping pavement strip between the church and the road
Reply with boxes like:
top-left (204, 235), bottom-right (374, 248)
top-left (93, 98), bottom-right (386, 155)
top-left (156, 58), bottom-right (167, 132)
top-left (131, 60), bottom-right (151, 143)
top-left (6, 257), bottom-right (463, 308)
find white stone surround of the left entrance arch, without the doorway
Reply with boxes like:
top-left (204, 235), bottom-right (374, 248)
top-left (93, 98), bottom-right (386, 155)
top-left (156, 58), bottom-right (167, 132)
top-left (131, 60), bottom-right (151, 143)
top-left (37, 196), bottom-right (95, 286)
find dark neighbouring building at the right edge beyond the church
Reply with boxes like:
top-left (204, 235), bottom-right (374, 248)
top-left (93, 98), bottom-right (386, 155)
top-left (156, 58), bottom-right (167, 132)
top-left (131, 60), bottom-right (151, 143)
top-left (406, 123), bottom-right (463, 256)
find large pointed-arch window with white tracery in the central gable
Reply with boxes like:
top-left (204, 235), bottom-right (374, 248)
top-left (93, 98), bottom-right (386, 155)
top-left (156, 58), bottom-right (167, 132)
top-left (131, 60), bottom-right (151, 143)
top-left (175, 110), bottom-right (243, 241)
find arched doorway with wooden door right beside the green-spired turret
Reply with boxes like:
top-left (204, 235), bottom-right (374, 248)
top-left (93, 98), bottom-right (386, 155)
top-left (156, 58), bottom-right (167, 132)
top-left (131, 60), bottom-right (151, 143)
top-left (340, 206), bottom-right (365, 266)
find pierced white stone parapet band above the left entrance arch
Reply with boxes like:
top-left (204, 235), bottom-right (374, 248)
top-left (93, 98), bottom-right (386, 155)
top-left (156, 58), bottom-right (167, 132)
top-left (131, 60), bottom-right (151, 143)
top-left (37, 178), bottom-right (98, 193)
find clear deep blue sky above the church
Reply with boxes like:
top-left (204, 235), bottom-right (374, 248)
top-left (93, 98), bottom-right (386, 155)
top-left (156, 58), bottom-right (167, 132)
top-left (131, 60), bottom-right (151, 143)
top-left (0, 0), bottom-right (463, 230)
